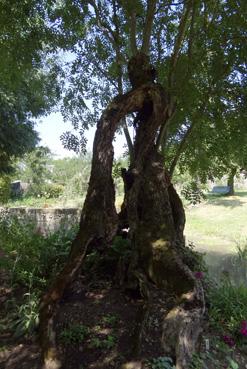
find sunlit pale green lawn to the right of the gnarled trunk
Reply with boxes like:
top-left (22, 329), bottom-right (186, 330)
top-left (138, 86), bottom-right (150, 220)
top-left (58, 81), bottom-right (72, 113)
top-left (185, 191), bottom-right (247, 279)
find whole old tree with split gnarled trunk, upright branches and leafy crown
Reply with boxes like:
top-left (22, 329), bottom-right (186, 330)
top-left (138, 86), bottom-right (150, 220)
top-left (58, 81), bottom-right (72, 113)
top-left (40, 0), bottom-right (245, 369)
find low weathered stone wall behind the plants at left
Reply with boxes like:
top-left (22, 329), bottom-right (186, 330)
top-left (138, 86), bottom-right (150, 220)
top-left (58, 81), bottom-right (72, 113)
top-left (0, 207), bottom-right (81, 234)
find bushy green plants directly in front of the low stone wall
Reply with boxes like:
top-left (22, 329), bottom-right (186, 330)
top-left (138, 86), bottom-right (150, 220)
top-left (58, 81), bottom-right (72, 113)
top-left (0, 214), bottom-right (75, 290)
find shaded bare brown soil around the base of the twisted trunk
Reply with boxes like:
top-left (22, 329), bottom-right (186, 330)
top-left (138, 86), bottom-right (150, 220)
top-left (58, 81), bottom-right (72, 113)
top-left (0, 250), bottom-right (247, 369)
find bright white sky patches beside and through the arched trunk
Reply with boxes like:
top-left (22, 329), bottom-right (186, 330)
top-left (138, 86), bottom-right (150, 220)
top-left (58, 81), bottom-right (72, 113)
top-left (35, 112), bottom-right (131, 158)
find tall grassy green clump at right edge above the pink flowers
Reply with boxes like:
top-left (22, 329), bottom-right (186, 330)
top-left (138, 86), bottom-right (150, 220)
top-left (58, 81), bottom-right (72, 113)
top-left (208, 279), bottom-right (247, 337)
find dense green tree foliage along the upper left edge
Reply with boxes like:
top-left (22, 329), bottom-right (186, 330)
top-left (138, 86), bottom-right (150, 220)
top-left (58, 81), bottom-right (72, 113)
top-left (0, 0), bottom-right (60, 173)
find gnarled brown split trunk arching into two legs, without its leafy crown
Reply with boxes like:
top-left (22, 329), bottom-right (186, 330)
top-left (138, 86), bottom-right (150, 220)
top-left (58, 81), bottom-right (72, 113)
top-left (40, 51), bottom-right (204, 369)
